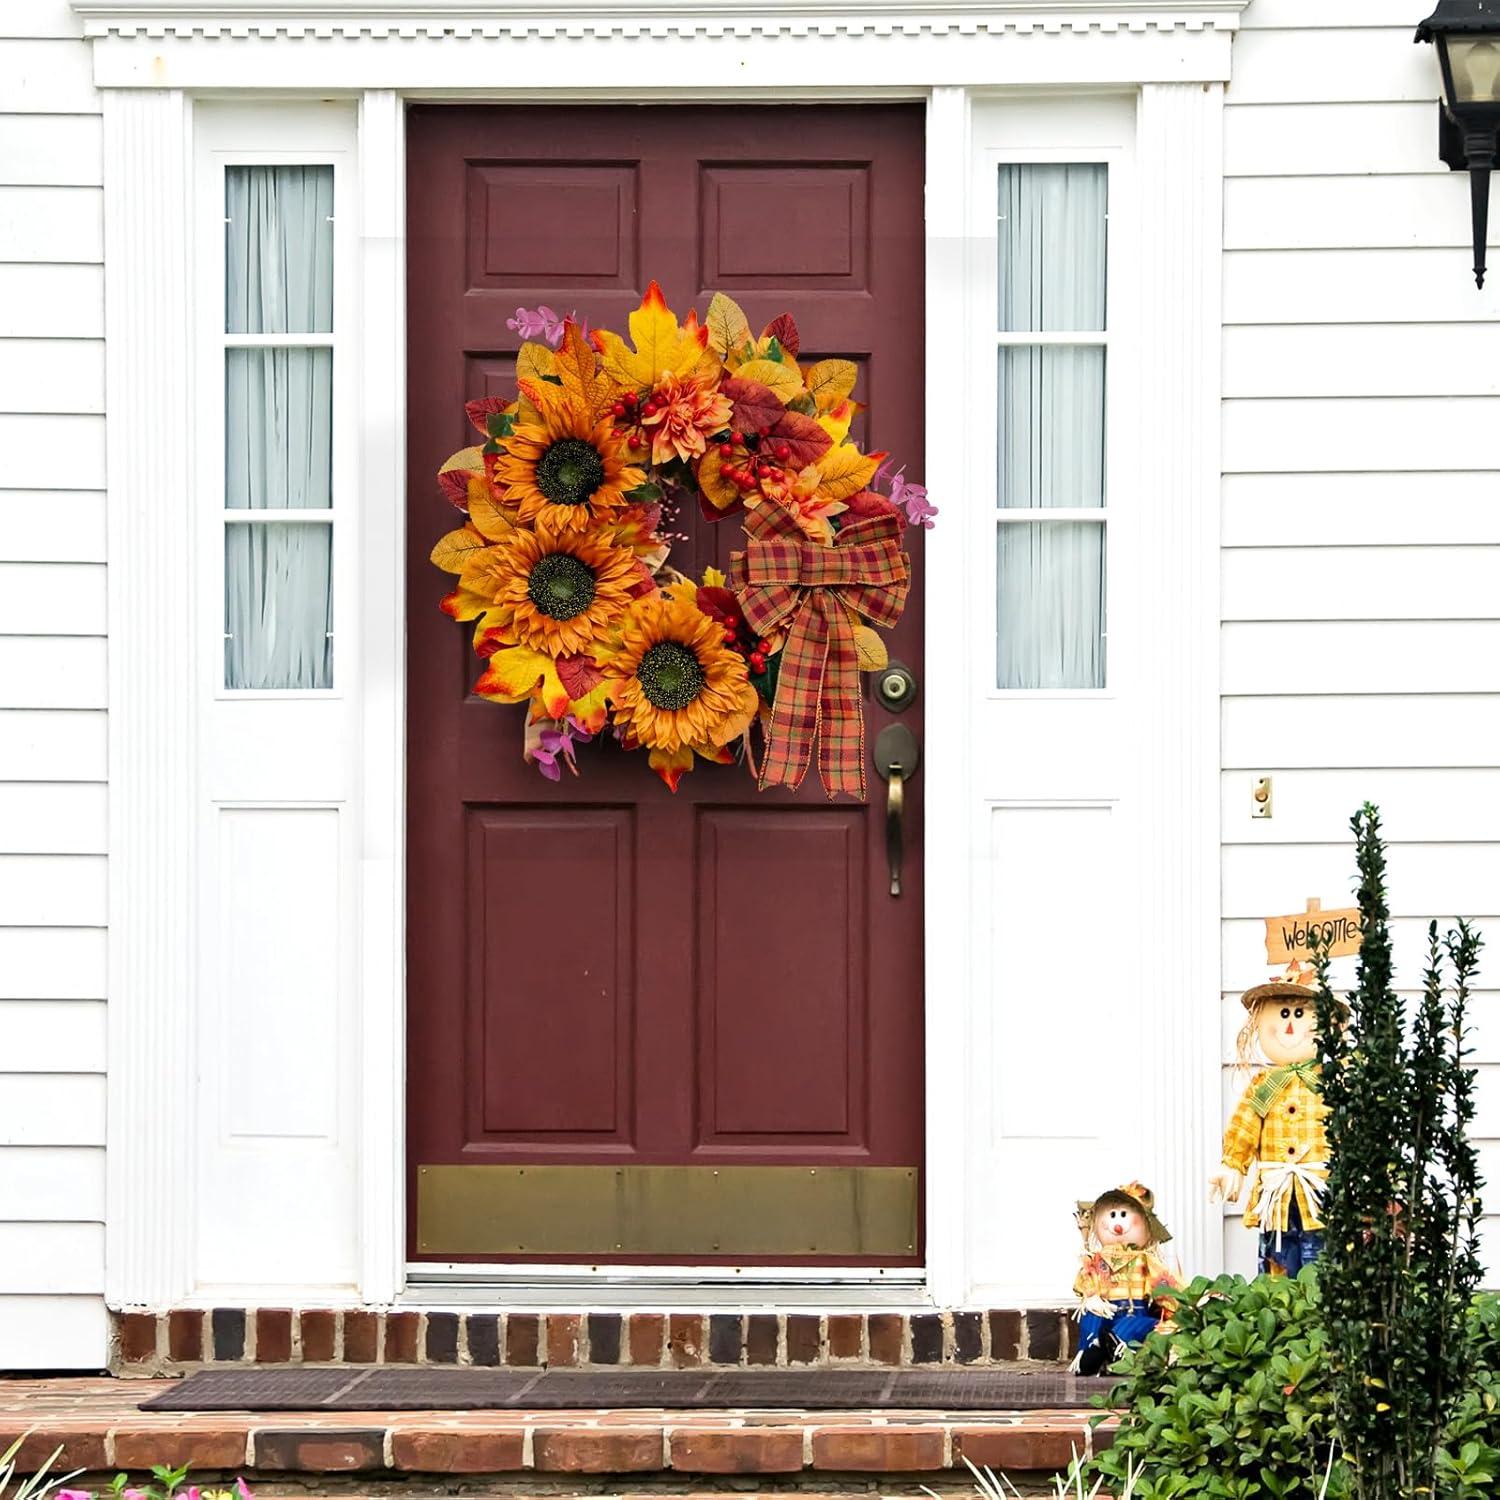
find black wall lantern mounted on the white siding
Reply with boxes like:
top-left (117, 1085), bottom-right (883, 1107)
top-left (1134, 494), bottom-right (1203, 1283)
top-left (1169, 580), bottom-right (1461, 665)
top-left (1416, 0), bottom-right (1500, 287)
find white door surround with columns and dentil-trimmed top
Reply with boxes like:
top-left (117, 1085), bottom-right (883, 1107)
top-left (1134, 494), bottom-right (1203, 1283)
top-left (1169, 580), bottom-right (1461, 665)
top-left (87, 0), bottom-right (1247, 1308)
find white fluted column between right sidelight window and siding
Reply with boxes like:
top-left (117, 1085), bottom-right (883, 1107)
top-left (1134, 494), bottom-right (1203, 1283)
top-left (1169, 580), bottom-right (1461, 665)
top-left (1131, 83), bottom-right (1224, 1274)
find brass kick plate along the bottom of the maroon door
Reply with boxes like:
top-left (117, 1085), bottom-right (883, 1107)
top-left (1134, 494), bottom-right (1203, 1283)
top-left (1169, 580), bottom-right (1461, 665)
top-left (417, 1166), bottom-right (918, 1259)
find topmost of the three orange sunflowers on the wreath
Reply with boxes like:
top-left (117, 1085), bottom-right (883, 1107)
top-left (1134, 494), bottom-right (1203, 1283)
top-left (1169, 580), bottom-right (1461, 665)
top-left (495, 393), bottom-right (647, 531)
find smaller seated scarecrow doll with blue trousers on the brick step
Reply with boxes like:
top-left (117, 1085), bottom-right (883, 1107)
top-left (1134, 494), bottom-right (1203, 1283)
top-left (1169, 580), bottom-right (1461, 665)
top-left (1073, 1182), bottom-right (1181, 1376)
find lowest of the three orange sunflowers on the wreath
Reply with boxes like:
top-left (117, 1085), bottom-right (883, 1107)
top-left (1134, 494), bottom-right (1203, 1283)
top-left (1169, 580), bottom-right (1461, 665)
top-left (605, 594), bottom-right (759, 759)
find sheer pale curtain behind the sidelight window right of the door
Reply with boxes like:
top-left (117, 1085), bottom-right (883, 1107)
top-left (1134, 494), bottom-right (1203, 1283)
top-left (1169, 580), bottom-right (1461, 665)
top-left (996, 164), bottom-right (1109, 689)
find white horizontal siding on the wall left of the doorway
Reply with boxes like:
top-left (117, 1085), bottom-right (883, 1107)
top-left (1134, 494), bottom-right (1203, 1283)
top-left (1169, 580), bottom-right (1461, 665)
top-left (0, 0), bottom-right (108, 1370)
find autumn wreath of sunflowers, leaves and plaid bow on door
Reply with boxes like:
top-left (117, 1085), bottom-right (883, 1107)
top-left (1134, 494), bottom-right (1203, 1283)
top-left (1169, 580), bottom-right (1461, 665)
top-left (432, 282), bottom-right (936, 797)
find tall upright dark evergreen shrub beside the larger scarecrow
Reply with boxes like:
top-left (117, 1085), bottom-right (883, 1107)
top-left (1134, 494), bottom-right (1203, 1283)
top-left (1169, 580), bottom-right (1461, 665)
top-left (1317, 803), bottom-right (1481, 1500)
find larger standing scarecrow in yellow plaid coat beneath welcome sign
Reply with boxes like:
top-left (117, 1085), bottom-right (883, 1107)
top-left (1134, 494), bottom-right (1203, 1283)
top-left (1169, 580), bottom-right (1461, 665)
top-left (1209, 959), bottom-right (1328, 1277)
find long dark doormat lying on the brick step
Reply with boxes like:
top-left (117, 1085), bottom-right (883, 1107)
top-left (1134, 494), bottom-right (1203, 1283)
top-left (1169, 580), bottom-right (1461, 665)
top-left (141, 1365), bottom-right (1112, 1412)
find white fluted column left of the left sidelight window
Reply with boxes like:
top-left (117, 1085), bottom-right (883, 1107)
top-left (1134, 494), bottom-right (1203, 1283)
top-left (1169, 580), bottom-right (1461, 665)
top-left (104, 89), bottom-right (197, 1308)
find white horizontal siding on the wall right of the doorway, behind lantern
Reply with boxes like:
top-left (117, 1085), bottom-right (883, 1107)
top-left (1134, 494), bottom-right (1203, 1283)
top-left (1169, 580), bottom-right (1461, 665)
top-left (1221, 0), bottom-right (1500, 1271)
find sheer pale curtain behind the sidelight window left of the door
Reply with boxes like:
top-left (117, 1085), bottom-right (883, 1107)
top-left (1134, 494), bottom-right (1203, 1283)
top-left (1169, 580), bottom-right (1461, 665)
top-left (224, 167), bottom-right (333, 689)
